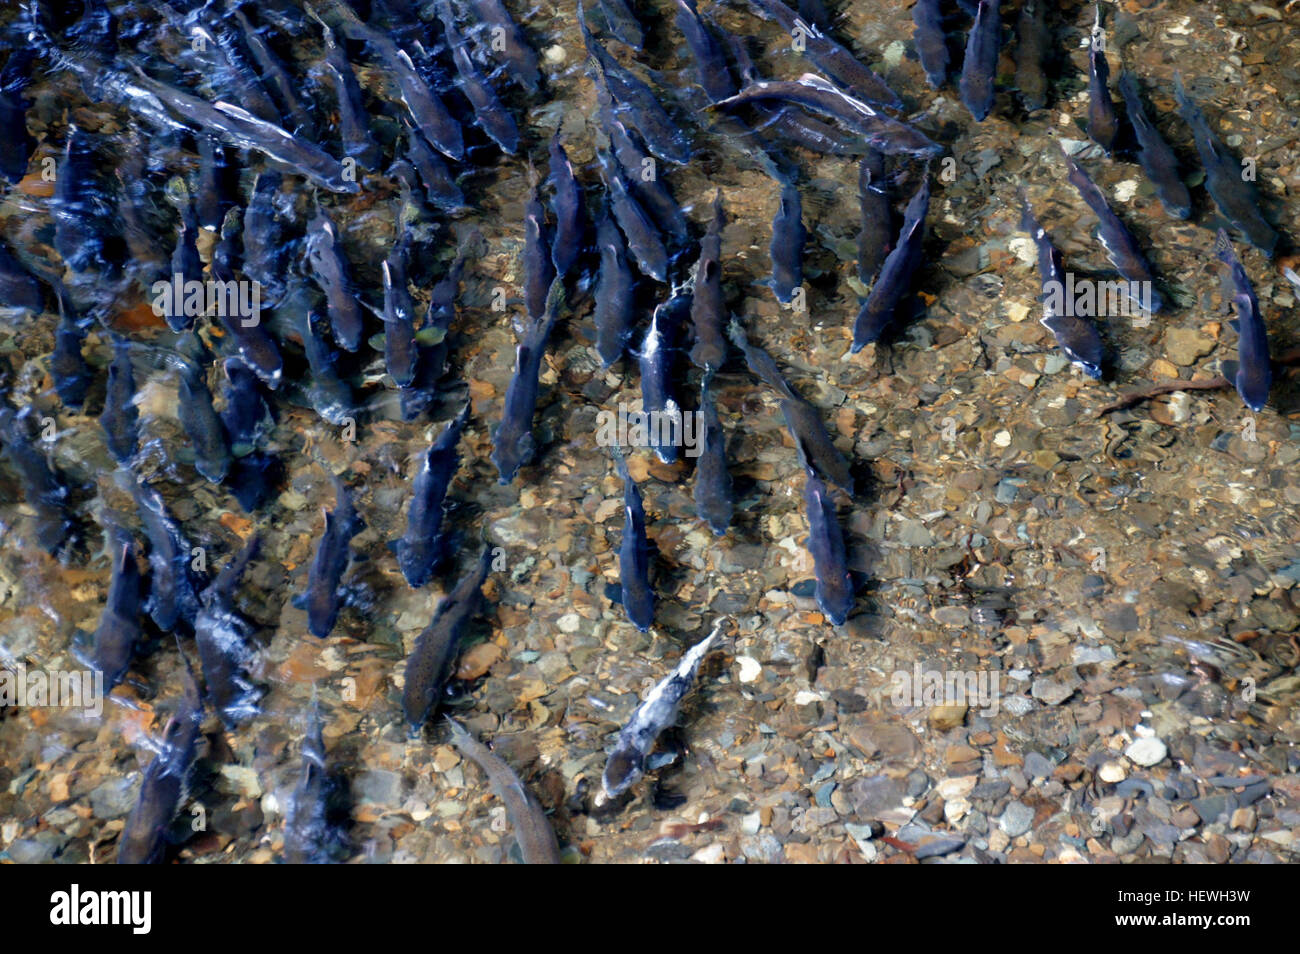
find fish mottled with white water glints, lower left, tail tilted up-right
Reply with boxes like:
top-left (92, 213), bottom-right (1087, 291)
top-left (194, 534), bottom-right (263, 730)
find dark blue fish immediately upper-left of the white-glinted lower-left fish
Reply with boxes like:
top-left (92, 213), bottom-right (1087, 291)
top-left (130, 468), bottom-right (207, 633)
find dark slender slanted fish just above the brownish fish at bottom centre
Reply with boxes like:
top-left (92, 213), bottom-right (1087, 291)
top-left (402, 546), bottom-right (493, 736)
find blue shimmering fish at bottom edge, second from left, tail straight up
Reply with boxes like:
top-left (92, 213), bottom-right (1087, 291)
top-left (285, 706), bottom-right (351, 864)
